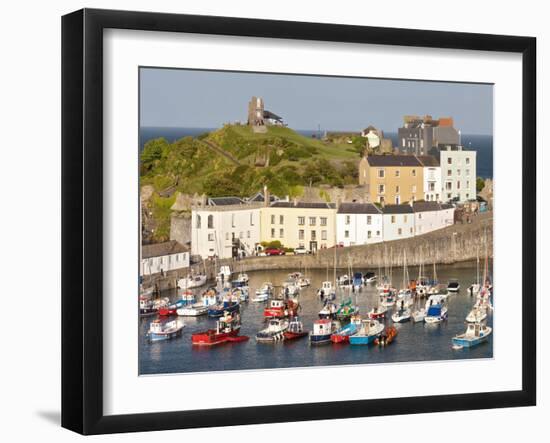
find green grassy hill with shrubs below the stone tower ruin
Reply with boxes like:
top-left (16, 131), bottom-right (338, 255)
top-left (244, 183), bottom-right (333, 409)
top-left (140, 125), bottom-right (360, 201)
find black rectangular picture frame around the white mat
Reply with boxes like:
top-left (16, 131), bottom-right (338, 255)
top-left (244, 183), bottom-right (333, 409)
top-left (62, 9), bottom-right (537, 434)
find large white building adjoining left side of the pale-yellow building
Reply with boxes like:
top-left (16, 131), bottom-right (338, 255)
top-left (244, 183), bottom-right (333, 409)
top-left (191, 197), bottom-right (263, 259)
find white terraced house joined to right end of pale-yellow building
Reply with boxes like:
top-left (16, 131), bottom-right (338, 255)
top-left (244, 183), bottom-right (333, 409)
top-left (336, 203), bottom-right (384, 246)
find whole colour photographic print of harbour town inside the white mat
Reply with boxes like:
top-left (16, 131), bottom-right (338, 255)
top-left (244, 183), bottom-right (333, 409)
top-left (135, 67), bottom-right (496, 375)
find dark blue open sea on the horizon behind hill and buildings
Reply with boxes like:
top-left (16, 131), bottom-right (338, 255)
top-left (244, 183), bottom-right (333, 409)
top-left (139, 126), bottom-right (493, 178)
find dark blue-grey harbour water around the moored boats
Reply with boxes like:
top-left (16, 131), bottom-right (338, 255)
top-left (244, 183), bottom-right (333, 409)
top-left (139, 263), bottom-right (495, 375)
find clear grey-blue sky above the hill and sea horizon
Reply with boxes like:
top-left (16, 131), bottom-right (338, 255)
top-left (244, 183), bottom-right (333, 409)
top-left (140, 68), bottom-right (493, 135)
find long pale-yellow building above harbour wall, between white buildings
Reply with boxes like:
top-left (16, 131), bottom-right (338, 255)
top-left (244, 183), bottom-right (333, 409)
top-left (260, 201), bottom-right (336, 252)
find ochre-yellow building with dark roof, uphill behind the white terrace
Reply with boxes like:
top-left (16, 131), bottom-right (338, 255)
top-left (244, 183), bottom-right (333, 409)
top-left (359, 155), bottom-right (430, 205)
